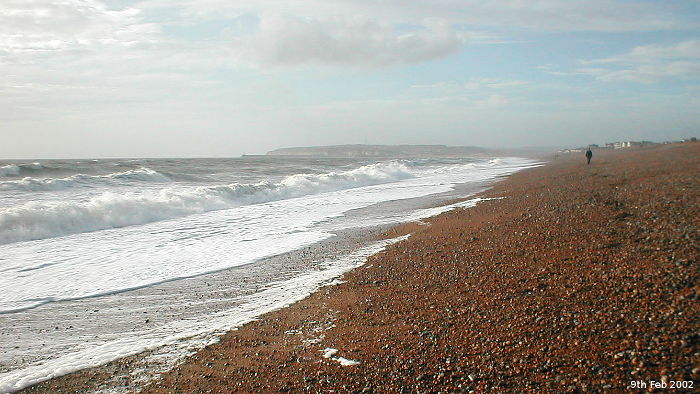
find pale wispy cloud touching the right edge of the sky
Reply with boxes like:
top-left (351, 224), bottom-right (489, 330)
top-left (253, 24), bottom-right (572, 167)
top-left (577, 40), bottom-right (700, 83)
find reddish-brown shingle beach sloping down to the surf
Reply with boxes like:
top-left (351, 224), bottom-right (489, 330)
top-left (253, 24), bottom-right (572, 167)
top-left (19, 144), bottom-right (700, 392)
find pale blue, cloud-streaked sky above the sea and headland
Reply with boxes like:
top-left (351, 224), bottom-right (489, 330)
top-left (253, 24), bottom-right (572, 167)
top-left (0, 0), bottom-right (700, 158)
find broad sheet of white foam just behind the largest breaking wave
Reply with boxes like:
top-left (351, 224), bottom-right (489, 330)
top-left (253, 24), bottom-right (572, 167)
top-left (0, 159), bottom-right (540, 312)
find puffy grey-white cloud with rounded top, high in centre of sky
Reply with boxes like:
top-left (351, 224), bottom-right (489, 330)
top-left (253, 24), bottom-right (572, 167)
top-left (233, 15), bottom-right (467, 66)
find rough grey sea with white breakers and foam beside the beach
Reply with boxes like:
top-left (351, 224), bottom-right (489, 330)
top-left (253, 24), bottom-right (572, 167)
top-left (0, 155), bottom-right (538, 392)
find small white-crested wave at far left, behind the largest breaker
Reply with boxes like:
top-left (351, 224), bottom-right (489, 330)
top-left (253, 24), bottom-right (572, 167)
top-left (0, 167), bottom-right (170, 191)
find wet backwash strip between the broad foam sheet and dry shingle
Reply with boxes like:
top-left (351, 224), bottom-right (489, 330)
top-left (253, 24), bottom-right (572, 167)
top-left (8, 159), bottom-right (510, 392)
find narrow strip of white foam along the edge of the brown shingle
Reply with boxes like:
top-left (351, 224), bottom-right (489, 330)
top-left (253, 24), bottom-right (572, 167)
top-left (0, 236), bottom-right (407, 393)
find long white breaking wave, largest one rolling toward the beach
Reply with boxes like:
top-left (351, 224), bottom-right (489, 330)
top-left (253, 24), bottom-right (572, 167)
top-left (0, 162), bottom-right (414, 244)
